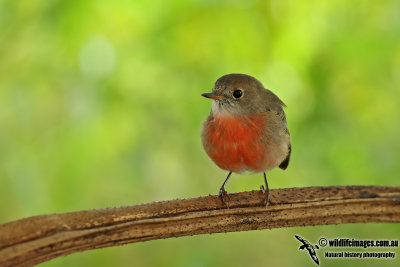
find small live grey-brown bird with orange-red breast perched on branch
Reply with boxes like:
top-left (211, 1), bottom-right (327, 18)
top-left (201, 73), bottom-right (291, 208)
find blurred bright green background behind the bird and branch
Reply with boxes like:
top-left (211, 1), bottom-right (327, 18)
top-left (0, 0), bottom-right (400, 266)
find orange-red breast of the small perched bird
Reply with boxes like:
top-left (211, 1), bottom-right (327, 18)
top-left (202, 113), bottom-right (277, 172)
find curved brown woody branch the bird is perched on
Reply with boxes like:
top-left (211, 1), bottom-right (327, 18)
top-left (0, 186), bottom-right (400, 266)
